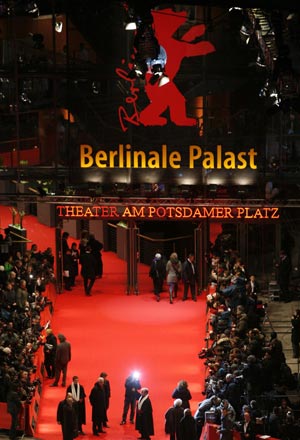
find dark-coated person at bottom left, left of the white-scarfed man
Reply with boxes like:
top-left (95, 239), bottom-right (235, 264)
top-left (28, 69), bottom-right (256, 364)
top-left (56, 393), bottom-right (78, 440)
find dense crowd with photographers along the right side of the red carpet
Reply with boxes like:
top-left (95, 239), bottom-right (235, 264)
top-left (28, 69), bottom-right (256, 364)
top-left (194, 250), bottom-right (300, 440)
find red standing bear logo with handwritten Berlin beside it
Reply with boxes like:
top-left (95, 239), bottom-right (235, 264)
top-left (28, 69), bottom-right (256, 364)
top-left (116, 9), bottom-right (215, 132)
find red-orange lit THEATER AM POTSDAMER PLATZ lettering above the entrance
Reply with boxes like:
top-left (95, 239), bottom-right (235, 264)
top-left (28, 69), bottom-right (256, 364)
top-left (56, 205), bottom-right (280, 220)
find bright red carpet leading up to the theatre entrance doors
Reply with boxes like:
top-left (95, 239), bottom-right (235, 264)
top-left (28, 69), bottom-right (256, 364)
top-left (1, 208), bottom-right (206, 440)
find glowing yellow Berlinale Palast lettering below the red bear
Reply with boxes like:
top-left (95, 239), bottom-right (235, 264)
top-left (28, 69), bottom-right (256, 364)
top-left (80, 144), bottom-right (257, 170)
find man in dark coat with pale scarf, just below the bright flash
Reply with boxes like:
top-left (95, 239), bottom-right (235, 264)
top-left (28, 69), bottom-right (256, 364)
top-left (135, 388), bottom-right (154, 440)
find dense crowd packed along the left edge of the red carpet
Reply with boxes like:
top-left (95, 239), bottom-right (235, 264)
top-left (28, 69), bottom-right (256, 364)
top-left (0, 232), bottom-right (55, 439)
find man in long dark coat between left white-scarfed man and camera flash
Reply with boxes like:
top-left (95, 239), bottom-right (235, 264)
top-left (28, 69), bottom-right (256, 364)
top-left (89, 377), bottom-right (107, 436)
